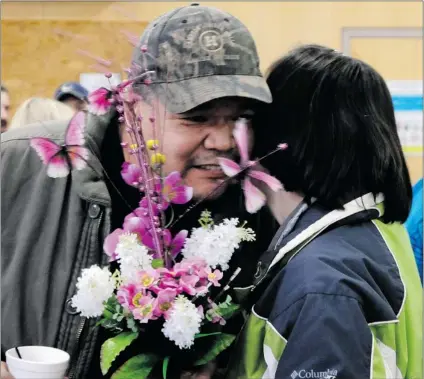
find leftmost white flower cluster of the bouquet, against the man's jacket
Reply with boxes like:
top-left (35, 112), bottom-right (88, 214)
top-left (72, 266), bottom-right (115, 317)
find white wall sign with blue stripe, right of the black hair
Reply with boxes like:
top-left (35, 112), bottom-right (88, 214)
top-left (387, 80), bottom-right (423, 155)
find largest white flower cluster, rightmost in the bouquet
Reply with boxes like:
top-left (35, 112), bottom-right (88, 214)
top-left (182, 218), bottom-right (255, 271)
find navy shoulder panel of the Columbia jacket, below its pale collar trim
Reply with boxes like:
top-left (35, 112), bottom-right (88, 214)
top-left (262, 222), bottom-right (405, 322)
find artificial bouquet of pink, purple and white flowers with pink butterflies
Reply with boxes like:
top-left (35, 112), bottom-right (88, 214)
top-left (32, 50), bottom-right (286, 379)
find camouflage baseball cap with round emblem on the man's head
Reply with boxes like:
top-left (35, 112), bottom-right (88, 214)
top-left (130, 3), bottom-right (272, 113)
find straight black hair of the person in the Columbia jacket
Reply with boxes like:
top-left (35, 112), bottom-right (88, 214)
top-left (254, 45), bottom-right (412, 222)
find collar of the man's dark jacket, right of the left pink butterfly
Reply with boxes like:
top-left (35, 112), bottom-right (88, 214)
top-left (72, 108), bottom-right (120, 207)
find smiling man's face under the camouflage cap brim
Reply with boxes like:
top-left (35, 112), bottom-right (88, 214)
top-left (123, 98), bottom-right (253, 199)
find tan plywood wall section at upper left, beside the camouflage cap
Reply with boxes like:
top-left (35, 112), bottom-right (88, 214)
top-left (1, 20), bottom-right (147, 112)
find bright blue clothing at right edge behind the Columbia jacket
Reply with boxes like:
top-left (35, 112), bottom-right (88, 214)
top-left (405, 178), bottom-right (423, 283)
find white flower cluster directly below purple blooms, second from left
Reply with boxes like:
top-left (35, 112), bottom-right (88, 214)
top-left (115, 233), bottom-right (153, 283)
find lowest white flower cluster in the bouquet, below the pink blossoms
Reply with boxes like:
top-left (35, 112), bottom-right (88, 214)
top-left (162, 295), bottom-right (203, 349)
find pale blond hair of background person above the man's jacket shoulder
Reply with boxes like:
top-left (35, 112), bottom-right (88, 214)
top-left (9, 97), bottom-right (75, 129)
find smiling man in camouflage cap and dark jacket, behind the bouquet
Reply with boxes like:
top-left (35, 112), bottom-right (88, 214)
top-left (1, 4), bottom-right (273, 379)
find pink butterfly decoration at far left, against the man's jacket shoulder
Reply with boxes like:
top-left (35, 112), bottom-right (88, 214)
top-left (30, 112), bottom-right (89, 178)
